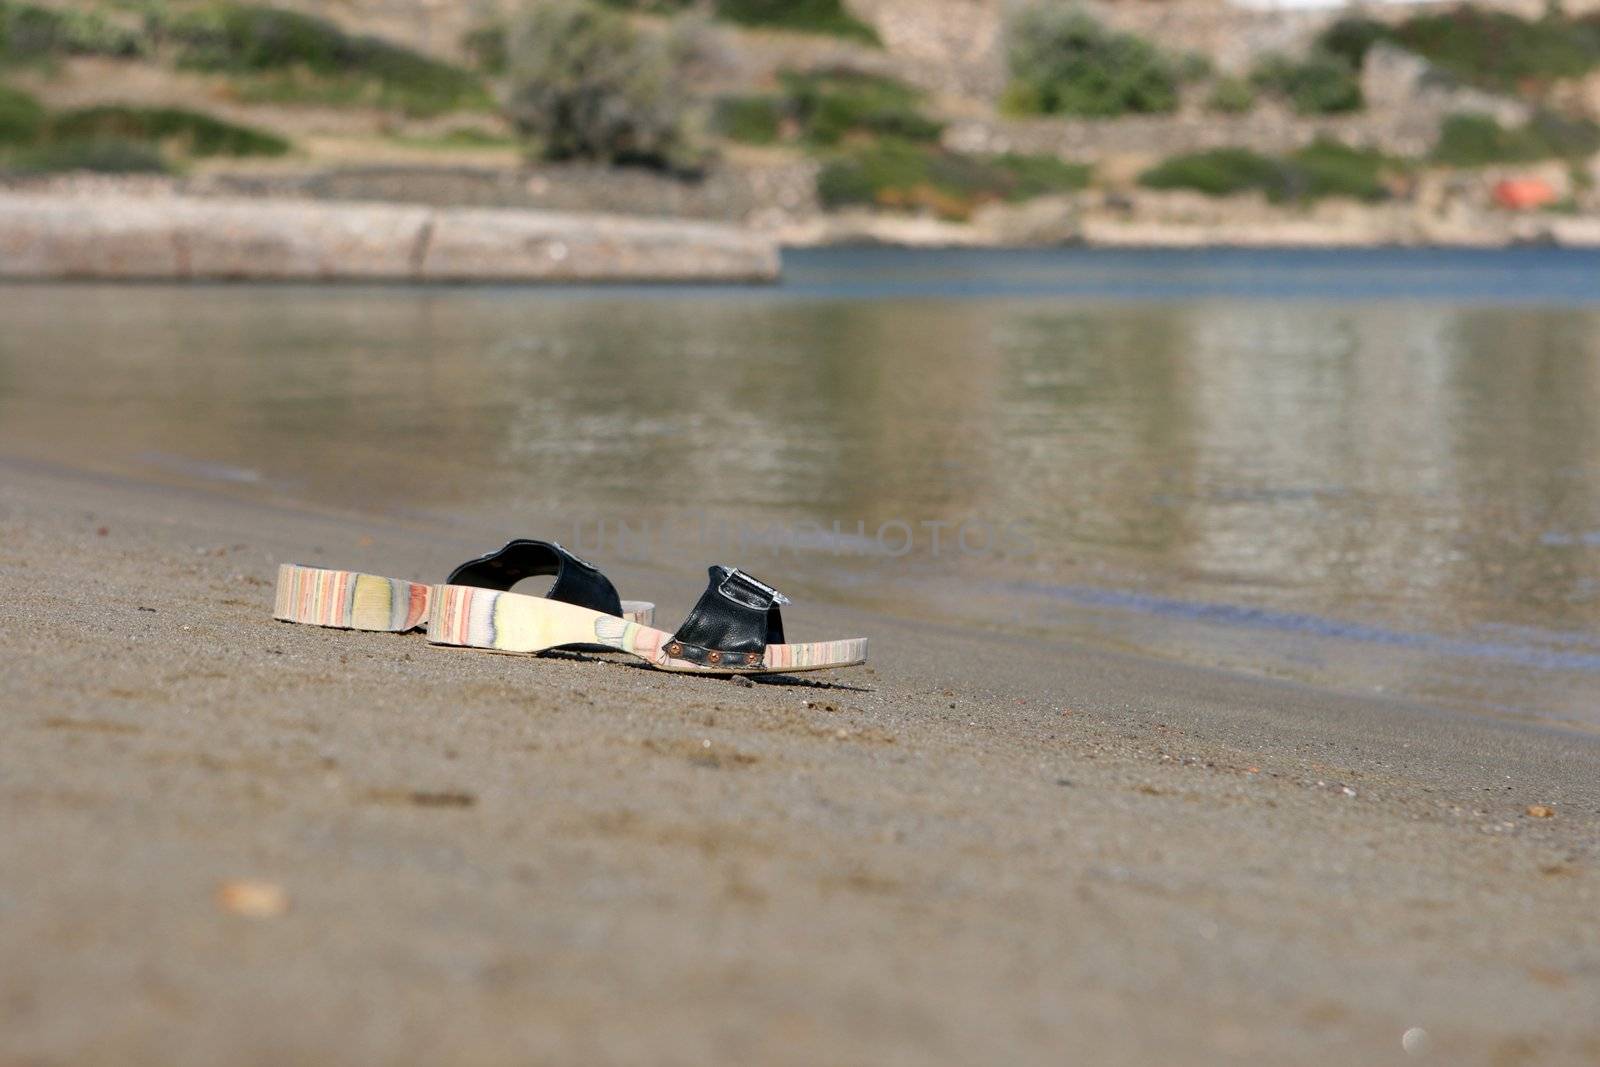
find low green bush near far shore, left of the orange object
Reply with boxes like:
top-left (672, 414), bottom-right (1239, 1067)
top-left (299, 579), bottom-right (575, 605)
top-left (1139, 141), bottom-right (1394, 203)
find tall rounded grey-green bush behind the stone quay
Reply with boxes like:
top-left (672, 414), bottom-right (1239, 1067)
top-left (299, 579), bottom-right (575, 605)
top-left (507, 0), bottom-right (699, 170)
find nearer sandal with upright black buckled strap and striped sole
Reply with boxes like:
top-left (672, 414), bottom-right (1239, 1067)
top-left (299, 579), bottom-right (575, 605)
top-left (427, 565), bottom-right (867, 673)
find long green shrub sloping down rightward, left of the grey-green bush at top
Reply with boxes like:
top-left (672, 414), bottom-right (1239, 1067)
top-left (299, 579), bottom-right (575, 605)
top-left (160, 3), bottom-right (488, 115)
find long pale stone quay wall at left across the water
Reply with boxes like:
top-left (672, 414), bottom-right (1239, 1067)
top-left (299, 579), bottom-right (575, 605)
top-left (0, 192), bottom-right (779, 283)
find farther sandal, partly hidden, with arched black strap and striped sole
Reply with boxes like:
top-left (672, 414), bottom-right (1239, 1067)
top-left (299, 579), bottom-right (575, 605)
top-left (272, 537), bottom-right (656, 633)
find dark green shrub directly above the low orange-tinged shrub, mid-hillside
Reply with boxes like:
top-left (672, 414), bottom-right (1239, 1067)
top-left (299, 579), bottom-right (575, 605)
top-left (781, 70), bottom-right (942, 146)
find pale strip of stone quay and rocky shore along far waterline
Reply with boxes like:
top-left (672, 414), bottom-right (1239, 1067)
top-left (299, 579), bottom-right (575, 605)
top-left (0, 177), bottom-right (1600, 285)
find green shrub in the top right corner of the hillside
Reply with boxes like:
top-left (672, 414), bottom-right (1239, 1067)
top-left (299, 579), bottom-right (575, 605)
top-left (1394, 6), bottom-right (1600, 93)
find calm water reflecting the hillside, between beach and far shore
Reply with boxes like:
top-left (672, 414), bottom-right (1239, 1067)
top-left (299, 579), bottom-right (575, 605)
top-left (0, 251), bottom-right (1600, 721)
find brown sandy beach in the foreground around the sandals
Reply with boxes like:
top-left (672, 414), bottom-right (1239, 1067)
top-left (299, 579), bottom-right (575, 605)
top-left (0, 461), bottom-right (1600, 1065)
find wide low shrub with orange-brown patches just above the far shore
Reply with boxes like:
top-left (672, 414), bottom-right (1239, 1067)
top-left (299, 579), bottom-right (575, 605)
top-left (818, 141), bottom-right (1088, 219)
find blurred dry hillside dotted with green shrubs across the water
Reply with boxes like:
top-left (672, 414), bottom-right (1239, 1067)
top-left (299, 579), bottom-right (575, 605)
top-left (0, 0), bottom-right (1600, 243)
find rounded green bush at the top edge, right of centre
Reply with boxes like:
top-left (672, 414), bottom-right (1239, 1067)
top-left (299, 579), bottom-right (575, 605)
top-left (1002, 5), bottom-right (1178, 117)
